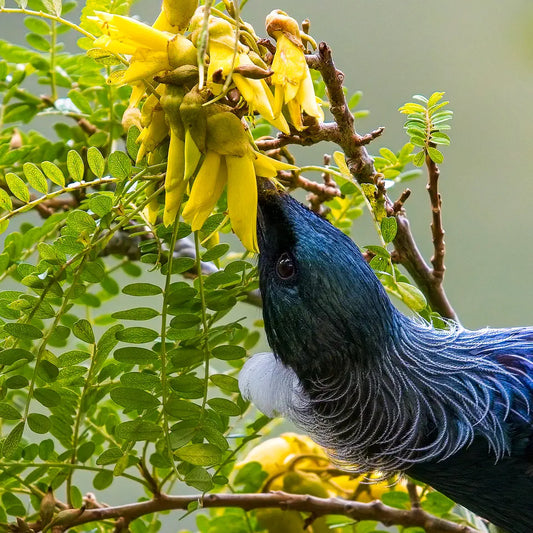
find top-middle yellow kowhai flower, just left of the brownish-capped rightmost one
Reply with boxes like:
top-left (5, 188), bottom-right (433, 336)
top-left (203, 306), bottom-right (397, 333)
top-left (191, 9), bottom-right (289, 134)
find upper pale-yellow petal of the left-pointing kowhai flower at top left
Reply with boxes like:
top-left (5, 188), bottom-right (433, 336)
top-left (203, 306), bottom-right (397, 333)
top-left (95, 11), bottom-right (169, 51)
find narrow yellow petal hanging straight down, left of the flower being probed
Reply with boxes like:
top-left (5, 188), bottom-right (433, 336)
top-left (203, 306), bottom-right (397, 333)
top-left (163, 132), bottom-right (187, 226)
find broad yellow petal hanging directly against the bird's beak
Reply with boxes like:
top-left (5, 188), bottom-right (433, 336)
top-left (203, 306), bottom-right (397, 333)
top-left (225, 154), bottom-right (258, 252)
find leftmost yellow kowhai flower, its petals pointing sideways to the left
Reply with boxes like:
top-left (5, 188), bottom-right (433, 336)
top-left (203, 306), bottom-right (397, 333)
top-left (92, 11), bottom-right (196, 85)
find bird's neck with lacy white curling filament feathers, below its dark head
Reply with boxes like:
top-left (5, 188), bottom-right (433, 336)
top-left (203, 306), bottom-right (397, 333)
top-left (295, 312), bottom-right (533, 471)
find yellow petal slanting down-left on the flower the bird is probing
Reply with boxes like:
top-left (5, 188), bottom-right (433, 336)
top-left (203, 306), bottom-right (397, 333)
top-left (183, 151), bottom-right (227, 231)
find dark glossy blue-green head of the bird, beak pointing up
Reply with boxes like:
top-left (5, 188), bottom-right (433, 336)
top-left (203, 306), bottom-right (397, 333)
top-left (258, 186), bottom-right (395, 380)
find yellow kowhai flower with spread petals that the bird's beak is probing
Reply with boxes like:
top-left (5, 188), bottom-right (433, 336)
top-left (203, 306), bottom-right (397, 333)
top-left (183, 104), bottom-right (297, 252)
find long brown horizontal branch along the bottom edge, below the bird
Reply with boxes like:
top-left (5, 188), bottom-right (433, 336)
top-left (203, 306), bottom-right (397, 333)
top-left (41, 492), bottom-right (479, 533)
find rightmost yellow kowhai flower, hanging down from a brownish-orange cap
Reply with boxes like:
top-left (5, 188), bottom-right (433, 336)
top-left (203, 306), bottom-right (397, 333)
top-left (266, 9), bottom-right (324, 131)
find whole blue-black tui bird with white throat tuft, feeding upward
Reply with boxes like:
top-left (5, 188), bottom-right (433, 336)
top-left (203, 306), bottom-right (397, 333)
top-left (239, 189), bottom-right (533, 533)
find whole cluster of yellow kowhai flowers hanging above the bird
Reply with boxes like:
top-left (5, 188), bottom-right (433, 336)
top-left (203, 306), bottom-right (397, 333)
top-left (90, 0), bottom-right (323, 251)
